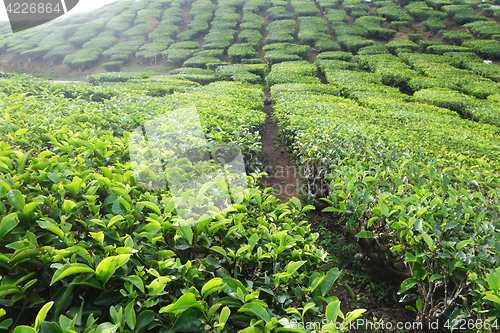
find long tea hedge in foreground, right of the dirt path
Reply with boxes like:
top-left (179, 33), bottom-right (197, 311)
top-left (272, 80), bottom-right (500, 325)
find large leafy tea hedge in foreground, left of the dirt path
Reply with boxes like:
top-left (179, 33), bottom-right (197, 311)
top-left (0, 76), bottom-right (363, 332)
